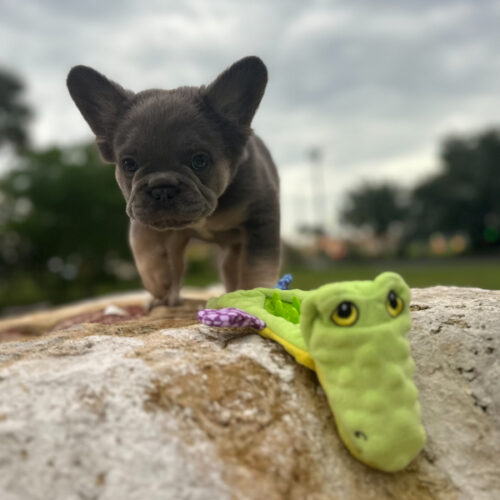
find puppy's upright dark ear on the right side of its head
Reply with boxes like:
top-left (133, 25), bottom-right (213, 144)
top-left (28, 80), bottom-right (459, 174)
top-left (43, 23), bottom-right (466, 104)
top-left (206, 56), bottom-right (267, 127)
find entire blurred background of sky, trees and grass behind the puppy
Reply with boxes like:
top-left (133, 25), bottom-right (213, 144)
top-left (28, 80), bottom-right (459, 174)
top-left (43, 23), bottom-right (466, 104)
top-left (0, 0), bottom-right (500, 315)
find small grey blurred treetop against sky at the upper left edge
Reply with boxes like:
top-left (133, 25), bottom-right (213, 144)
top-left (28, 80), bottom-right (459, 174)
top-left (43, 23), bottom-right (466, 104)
top-left (0, 70), bottom-right (31, 151)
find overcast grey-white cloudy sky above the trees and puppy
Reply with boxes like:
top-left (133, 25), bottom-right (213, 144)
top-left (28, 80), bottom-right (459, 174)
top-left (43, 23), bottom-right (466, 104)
top-left (0, 0), bottom-right (500, 238)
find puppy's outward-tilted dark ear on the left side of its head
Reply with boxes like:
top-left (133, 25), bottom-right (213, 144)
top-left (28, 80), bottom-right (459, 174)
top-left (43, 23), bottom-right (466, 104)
top-left (66, 66), bottom-right (134, 163)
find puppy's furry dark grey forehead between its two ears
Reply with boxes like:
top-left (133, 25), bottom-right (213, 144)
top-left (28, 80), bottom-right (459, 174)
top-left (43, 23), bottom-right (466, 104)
top-left (115, 89), bottom-right (222, 159)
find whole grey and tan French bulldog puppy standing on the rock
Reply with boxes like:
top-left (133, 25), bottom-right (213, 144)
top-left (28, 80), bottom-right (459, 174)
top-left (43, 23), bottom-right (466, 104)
top-left (67, 57), bottom-right (280, 305)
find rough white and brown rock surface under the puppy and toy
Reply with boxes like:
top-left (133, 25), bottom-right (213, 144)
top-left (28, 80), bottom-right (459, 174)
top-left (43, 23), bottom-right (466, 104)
top-left (0, 287), bottom-right (500, 500)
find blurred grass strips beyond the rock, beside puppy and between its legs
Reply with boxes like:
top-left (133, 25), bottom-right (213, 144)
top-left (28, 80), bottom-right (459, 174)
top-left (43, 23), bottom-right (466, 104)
top-left (0, 256), bottom-right (500, 316)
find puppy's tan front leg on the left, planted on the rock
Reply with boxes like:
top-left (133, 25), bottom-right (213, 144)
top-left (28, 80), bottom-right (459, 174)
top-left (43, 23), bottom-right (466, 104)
top-left (130, 222), bottom-right (189, 306)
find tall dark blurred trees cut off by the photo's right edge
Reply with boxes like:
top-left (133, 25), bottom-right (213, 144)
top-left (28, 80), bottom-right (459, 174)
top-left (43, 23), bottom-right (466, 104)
top-left (408, 130), bottom-right (500, 250)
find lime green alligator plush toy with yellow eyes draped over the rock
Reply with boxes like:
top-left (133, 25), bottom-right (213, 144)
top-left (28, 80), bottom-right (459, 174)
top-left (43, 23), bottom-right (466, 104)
top-left (198, 273), bottom-right (426, 472)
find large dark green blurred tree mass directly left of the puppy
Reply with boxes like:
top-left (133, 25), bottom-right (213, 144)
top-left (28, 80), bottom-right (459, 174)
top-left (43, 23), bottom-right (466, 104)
top-left (0, 146), bottom-right (139, 307)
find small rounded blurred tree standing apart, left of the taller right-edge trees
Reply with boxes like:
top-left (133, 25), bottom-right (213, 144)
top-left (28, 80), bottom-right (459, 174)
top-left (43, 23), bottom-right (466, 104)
top-left (340, 184), bottom-right (407, 236)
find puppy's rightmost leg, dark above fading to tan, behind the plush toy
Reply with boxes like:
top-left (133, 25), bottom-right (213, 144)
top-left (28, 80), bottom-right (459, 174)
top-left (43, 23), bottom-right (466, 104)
top-left (238, 211), bottom-right (281, 289)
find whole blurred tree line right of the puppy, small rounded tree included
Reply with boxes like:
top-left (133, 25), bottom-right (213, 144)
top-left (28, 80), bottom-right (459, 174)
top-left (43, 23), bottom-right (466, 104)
top-left (342, 130), bottom-right (500, 251)
